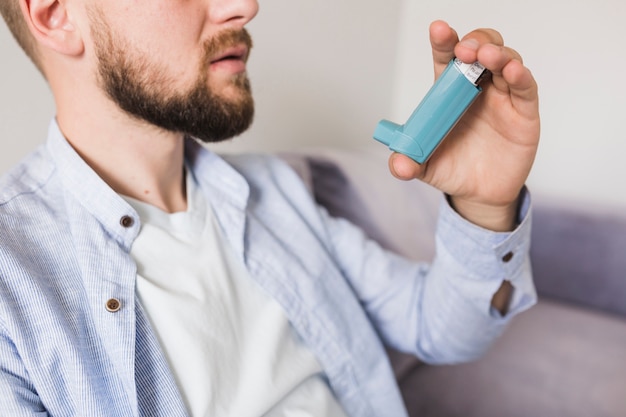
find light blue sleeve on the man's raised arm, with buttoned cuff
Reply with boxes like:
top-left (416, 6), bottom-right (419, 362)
top-left (327, 189), bottom-right (537, 363)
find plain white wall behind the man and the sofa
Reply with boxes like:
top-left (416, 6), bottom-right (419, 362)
top-left (0, 0), bottom-right (626, 205)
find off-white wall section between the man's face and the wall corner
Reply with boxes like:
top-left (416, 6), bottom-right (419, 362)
top-left (224, 0), bottom-right (403, 154)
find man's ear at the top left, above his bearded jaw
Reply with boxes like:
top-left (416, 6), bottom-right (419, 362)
top-left (19, 0), bottom-right (84, 56)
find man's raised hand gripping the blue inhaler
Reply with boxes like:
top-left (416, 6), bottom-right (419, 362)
top-left (389, 21), bottom-right (540, 231)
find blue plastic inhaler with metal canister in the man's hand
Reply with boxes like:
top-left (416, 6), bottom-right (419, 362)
top-left (374, 58), bottom-right (488, 164)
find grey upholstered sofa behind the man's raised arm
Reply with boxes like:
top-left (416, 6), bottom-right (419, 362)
top-left (281, 149), bottom-right (626, 417)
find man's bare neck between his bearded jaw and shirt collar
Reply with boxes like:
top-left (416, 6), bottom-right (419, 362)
top-left (57, 88), bottom-right (187, 213)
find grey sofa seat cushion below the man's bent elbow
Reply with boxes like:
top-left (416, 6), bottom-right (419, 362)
top-left (399, 300), bottom-right (626, 417)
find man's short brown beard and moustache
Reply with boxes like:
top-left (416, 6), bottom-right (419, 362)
top-left (91, 12), bottom-right (254, 142)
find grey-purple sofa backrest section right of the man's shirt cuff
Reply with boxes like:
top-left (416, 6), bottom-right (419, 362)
top-left (531, 196), bottom-right (626, 316)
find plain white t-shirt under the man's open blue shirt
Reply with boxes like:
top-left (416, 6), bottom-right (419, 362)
top-left (122, 175), bottom-right (345, 417)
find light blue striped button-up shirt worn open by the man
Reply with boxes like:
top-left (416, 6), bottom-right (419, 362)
top-left (0, 118), bottom-right (536, 417)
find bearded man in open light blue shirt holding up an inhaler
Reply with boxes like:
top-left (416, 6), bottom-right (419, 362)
top-left (0, 0), bottom-right (539, 417)
